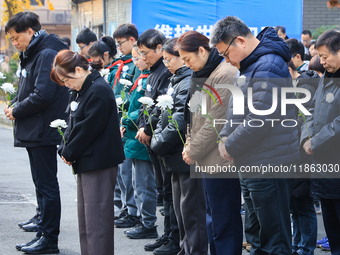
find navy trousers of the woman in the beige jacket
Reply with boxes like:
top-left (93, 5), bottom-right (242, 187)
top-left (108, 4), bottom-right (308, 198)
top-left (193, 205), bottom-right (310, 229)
top-left (203, 175), bottom-right (243, 255)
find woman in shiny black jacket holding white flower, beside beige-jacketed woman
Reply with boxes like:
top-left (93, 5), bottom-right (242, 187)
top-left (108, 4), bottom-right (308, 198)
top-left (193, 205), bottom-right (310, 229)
top-left (151, 38), bottom-right (208, 255)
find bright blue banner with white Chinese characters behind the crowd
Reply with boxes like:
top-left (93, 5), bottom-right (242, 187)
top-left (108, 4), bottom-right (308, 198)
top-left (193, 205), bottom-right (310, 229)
top-left (132, 0), bottom-right (303, 39)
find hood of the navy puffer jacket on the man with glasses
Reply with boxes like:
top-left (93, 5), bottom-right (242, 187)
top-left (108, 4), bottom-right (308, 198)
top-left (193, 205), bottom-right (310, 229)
top-left (240, 27), bottom-right (291, 70)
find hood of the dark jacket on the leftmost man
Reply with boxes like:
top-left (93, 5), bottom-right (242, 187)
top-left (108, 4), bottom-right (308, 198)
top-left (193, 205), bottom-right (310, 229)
top-left (21, 30), bottom-right (68, 58)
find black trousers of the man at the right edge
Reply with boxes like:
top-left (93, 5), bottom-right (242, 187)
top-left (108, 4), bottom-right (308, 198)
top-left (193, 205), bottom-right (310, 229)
top-left (320, 198), bottom-right (340, 255)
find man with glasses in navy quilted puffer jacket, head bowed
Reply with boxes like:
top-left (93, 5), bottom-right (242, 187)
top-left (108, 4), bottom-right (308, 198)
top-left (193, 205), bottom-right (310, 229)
top-left (214, 16), bottom-right (299, 255)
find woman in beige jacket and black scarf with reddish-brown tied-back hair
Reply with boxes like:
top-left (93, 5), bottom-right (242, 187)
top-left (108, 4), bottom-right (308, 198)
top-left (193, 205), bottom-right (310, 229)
top-left (177, 31), bottom-right (243, 255)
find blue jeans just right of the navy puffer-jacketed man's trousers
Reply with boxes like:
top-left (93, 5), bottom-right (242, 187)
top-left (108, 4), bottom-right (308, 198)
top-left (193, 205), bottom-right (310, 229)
top-left (291, 196), bottom-right (317, 255)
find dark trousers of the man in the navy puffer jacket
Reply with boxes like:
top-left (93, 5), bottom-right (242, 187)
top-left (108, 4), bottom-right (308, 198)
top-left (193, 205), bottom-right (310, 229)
top-left (240, 178), bottom-right (293, 255)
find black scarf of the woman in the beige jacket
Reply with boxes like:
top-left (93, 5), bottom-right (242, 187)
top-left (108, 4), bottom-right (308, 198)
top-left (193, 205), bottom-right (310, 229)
top-left (184, 48), bottom-right (223, 123)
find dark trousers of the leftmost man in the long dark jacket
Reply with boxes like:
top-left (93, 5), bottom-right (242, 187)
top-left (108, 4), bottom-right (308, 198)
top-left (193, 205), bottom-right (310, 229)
top-left (26, 146), bottom-right (61, 242)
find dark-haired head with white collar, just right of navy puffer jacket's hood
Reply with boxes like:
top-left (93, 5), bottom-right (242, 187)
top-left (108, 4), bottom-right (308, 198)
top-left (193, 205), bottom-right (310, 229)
top-left (286, 38), bottom-right (309, 72)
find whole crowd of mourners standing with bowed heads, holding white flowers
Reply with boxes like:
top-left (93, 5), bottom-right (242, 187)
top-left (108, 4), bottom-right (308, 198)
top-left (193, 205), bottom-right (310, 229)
top-left (5, 12), bottom-right (340, 255)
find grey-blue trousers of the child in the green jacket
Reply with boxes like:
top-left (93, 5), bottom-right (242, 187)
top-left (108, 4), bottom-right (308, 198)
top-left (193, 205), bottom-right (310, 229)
top-left (132, 159), bottom-right (157, 229)
